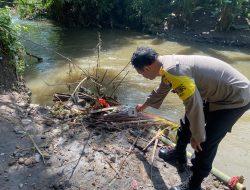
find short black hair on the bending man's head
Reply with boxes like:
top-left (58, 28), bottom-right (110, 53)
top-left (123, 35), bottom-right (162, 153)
top-left (131, 47), bottom-right (158, 70)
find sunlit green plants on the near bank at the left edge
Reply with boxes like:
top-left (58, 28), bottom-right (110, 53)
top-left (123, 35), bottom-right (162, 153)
top-left (0, 8), bottom-right (25, 91)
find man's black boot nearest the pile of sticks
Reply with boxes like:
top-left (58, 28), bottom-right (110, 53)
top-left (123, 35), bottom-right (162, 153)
top-left (159, 147), bottom-right (187, 172)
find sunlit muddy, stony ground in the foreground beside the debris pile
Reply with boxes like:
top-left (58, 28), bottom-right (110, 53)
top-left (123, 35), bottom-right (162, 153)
top-left (0, 92), bottom-right (228, 190)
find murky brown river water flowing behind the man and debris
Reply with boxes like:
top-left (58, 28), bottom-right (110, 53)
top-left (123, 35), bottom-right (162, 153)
top-left (14, 19), bottom-right (250, 187)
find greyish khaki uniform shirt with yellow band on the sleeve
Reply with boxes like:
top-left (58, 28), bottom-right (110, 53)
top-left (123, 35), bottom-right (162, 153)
top-left (146, 55), bottom-right (250, 142)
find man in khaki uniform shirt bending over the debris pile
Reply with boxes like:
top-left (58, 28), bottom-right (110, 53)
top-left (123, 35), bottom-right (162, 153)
top-left (131, 47), bottom-right (250, 190)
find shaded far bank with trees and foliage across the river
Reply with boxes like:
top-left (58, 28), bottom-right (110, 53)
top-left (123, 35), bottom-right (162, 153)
top-left (4, 0), bottom-right (250, 48)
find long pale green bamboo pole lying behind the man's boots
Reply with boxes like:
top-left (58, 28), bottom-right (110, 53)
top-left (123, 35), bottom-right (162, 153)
top-left (149, 130), bottom-right (246, 190)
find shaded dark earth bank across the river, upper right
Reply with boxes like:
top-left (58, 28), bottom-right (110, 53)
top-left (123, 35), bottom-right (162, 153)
top-left (145, 15), bottom-right (250, 50)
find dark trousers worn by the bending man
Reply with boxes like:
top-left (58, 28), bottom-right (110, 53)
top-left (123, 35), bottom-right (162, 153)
top-left (176, 103), bottom-right (250, 185)
